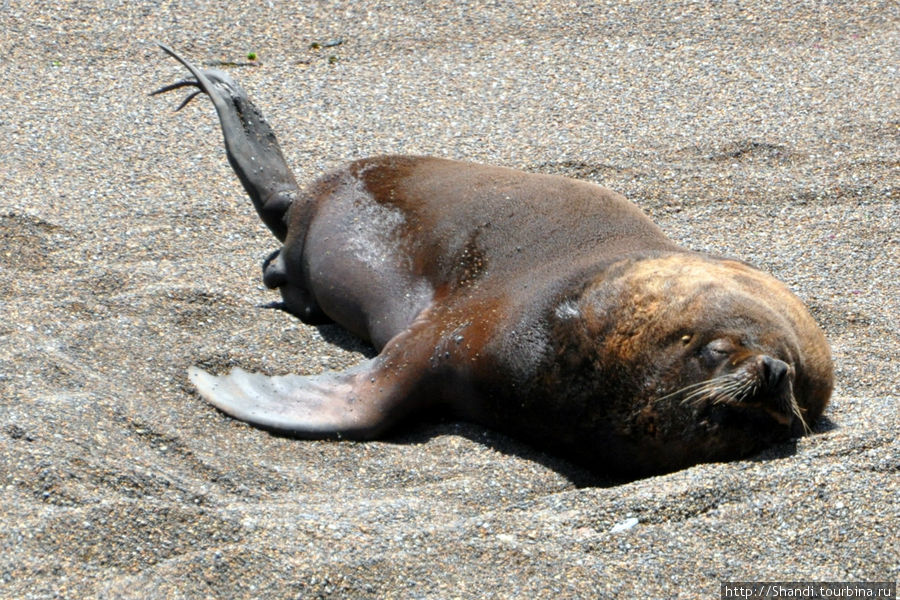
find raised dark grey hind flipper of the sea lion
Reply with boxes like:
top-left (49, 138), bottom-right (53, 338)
top-left (151, 44), bottom-right (300, 241)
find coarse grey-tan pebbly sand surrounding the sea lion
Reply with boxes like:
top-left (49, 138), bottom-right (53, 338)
top-left (0, 0), bottom-right (900, 598)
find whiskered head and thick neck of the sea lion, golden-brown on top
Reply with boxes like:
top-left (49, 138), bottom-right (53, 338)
top-left (557, 253), bottom-right (833, 473)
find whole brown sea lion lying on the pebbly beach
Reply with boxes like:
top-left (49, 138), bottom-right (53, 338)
top-left (154, 46), bottom-right (833, 477)
